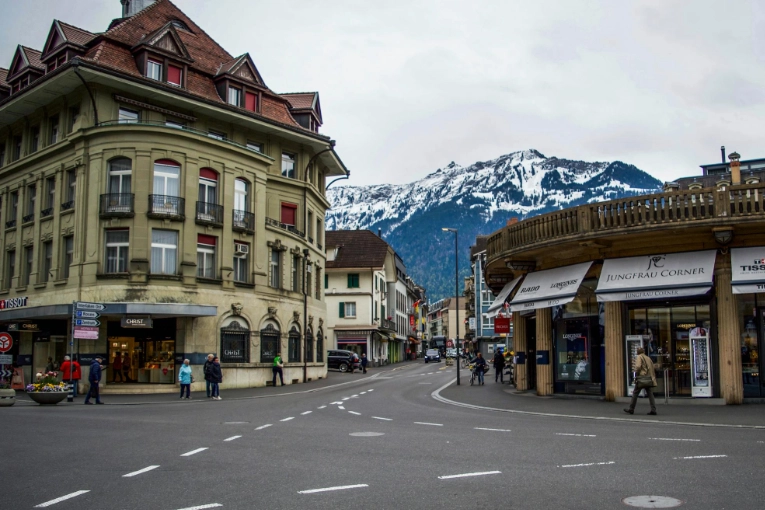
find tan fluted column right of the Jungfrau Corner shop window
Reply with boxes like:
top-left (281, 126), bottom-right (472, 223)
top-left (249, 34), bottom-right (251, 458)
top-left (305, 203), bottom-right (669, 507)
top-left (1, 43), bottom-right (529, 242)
top-left (715, 253), bottom-right (744, 404)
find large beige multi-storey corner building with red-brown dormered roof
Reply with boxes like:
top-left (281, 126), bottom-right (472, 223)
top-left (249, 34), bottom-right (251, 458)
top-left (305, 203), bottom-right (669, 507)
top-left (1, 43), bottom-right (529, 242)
top-left (0, 0), bottom-right (349, 392)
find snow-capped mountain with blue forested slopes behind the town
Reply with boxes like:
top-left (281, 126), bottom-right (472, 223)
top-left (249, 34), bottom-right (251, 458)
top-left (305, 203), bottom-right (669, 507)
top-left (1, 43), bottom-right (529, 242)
top-left (326, 149), bottom-right (661, 301)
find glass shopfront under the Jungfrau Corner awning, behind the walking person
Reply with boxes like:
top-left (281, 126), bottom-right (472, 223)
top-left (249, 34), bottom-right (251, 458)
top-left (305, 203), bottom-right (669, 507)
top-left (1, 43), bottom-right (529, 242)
top-left (626, 303), bottom-right (715, 397)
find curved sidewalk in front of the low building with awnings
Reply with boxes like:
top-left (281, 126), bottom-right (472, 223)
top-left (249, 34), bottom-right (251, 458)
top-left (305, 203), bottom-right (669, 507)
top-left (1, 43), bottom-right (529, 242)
top-left (433, 377), bottom-right (765, 429)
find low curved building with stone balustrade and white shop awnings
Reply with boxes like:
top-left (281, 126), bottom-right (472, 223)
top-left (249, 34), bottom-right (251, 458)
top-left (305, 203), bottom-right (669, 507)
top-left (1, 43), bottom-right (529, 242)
top-left (485, 153), bottom-right (765, 404)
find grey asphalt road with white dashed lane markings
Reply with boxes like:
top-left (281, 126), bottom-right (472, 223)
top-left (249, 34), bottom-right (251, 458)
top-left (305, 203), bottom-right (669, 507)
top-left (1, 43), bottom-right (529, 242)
top-left (5, 363), bottom-right (765, 510)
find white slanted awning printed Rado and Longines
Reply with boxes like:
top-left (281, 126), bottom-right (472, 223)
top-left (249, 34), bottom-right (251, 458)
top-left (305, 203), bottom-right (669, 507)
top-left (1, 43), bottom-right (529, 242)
top-left (510, 262), bottom-right (592, 312)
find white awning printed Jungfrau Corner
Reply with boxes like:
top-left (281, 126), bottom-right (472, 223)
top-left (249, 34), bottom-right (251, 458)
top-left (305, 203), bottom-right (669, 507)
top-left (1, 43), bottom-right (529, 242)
top-left (595, 250), bottom-right (717, 302)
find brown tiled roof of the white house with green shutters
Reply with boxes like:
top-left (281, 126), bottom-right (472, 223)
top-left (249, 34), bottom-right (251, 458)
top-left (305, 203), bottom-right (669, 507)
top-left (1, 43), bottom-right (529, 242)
top-left (325, 230), bottom-right (388, 269)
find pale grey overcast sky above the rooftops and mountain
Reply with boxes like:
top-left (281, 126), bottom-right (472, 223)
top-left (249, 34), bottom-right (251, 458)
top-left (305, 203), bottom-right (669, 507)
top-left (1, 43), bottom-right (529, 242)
top-left (0, 0), bottom-right (765, 185)
